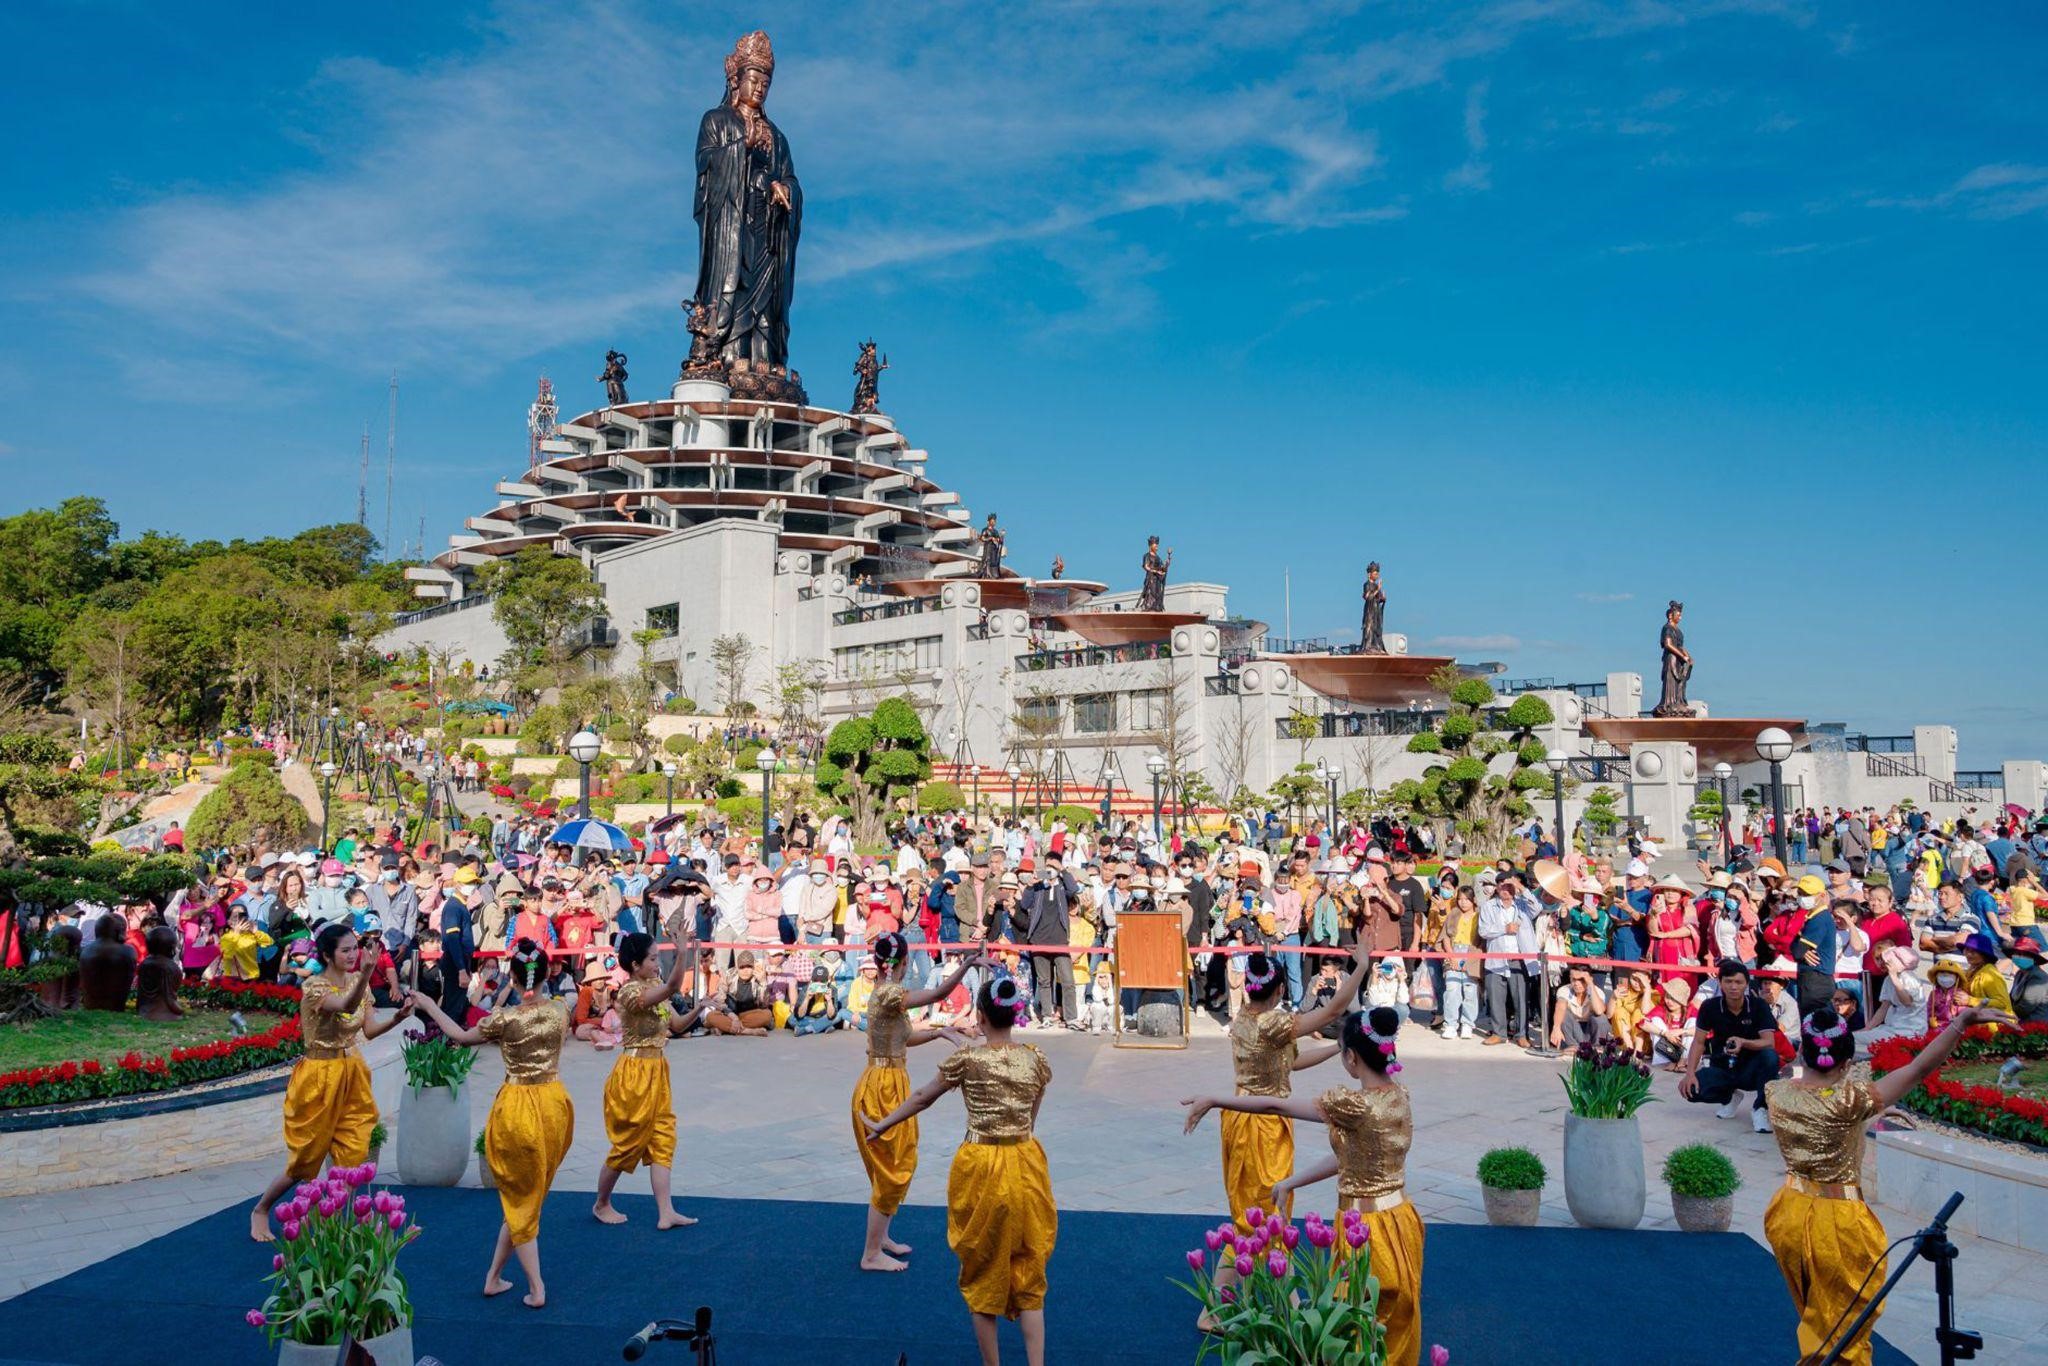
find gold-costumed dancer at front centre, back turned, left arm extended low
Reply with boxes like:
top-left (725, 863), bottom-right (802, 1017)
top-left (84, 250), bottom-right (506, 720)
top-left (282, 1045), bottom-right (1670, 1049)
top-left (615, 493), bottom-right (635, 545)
top-left (866, 977), bottom-right (1059, 1366)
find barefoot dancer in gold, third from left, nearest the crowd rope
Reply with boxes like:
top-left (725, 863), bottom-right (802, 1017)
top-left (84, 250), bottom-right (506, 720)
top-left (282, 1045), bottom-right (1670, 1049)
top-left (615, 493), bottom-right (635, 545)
top-left (590, 926), bottom-right (724, 1229)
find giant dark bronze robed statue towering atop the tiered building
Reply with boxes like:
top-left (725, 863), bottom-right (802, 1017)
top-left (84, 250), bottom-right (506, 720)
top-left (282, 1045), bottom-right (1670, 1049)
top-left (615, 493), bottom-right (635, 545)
top-left (684, 29), bottom-right (803, 401)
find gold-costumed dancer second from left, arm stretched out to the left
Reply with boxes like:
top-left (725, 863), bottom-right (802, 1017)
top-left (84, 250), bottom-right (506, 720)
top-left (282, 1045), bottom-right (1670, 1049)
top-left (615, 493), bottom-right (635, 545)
top-left (412, 940), bottom-right (575, 1309)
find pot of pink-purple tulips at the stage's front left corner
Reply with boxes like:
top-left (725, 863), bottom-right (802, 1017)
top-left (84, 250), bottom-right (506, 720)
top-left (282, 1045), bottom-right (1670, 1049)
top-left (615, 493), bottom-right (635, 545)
top-left (244, 1163), bottom-right (420, 1366)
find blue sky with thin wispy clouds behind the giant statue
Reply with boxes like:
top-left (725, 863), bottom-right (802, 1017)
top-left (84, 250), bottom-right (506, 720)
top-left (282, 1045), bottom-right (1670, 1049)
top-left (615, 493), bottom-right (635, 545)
top-left (0, 0), bottom-right (2048, 766)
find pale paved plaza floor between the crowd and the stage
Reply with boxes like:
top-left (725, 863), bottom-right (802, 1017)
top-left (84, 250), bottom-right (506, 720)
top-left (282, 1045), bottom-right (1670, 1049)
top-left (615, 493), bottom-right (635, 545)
top-left (0, 1022), bottom-right (2048, 1362)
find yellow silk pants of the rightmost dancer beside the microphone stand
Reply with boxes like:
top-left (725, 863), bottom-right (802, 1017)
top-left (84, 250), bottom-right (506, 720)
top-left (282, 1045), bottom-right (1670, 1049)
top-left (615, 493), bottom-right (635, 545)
top-left (1763, 1186), bottom-right (1886, 1366)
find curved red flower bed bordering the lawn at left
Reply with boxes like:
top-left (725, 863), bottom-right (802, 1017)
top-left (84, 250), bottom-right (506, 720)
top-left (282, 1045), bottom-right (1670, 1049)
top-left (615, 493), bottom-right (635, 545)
top-left (0, 983), bottom-right (305, 1110)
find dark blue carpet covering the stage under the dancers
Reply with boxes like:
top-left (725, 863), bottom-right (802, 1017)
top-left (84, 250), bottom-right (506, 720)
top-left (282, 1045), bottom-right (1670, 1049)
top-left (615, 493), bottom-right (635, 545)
top-left (0, 1190), bottom-right (1923, 1366)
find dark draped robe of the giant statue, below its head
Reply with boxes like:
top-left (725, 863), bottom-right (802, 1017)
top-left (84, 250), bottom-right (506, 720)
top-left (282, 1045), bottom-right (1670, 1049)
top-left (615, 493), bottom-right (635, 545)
top-left (696, 104), bottom-right (803, 367)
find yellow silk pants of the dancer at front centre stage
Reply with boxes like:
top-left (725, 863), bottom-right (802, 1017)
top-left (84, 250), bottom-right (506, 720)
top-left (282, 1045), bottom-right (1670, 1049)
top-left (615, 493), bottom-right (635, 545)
top-left (946, 1139), bottom-right (1059, 1319)
